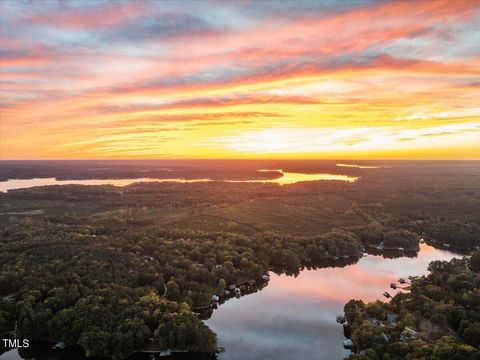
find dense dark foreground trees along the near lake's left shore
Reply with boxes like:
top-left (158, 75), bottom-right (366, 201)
top-left (0, 219), bottom-right (361, 358)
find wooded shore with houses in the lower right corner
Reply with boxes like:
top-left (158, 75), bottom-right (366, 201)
top-left (344, 252), bottom-right (480, 360)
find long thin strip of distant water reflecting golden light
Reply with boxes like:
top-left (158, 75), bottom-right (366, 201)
top-left (0, 170), bottom-right (358, 192)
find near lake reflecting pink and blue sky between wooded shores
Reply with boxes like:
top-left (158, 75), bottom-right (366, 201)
top-left (0, 243), bottom-right (460, 360)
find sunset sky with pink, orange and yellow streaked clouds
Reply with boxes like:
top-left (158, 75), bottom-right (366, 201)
top-left (0, 0), bottom-right (480, 159)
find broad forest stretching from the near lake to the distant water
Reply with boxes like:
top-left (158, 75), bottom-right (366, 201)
top-left (0, 164), bottom-right (480, 359)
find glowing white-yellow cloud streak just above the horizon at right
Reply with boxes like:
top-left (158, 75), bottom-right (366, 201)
top-left (211, 123), bottom-right (480, 154)
